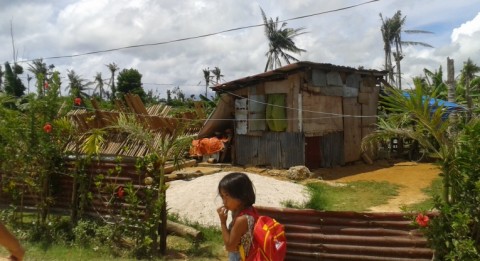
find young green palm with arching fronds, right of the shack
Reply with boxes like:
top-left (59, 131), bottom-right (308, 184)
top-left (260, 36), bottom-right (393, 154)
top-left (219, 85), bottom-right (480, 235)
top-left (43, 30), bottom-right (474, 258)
top-left (362, 87), bottom-right (457, 203)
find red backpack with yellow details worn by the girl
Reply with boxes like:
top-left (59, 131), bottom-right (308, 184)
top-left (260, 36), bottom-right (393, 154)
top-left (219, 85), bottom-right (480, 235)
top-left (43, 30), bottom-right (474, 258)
top-left (238, 209), bottom-right (287, 261)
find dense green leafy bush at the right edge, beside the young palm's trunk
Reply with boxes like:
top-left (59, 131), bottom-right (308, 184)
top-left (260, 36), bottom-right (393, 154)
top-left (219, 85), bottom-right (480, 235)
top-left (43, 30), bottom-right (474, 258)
top-left (423, 119), bottom-right (480, 261)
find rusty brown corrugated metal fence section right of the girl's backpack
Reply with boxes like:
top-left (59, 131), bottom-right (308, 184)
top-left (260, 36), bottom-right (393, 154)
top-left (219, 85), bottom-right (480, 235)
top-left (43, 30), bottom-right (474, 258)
top-left (257, 207), bottom-right (433, 261)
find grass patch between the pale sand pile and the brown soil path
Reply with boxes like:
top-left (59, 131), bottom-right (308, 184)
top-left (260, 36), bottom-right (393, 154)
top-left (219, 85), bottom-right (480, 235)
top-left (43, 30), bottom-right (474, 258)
top-left (286, 181), bottom-right (400, 212)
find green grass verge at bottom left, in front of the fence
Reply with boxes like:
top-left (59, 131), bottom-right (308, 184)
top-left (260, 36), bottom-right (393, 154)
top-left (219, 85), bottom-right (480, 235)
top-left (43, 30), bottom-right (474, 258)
top-left (0, 214), bottom-right (226, 261)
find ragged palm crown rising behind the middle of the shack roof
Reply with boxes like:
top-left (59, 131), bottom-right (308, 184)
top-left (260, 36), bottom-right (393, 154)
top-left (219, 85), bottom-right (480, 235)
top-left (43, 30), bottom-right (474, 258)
top-left (260, 8), bottom-right (306, 72)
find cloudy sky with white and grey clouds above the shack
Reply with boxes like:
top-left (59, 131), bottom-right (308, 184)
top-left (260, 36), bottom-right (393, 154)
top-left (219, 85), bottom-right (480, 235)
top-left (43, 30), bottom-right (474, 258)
top-left (0, 0), bottom-right (480, 97)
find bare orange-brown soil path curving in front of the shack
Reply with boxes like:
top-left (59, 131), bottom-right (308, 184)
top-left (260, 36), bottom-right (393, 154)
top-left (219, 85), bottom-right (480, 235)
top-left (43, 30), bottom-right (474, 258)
top-left (315, 162), bottom-right (440, 212)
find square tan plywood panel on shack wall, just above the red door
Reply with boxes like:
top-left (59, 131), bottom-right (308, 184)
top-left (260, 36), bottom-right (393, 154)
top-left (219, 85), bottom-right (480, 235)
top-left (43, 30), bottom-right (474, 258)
top-left (302, 92), bottom-right (343, 137)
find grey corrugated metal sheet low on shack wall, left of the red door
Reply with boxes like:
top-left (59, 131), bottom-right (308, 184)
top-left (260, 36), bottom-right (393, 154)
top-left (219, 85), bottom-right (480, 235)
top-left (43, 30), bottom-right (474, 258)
top-left (235, 132), bottom-right (304, 169)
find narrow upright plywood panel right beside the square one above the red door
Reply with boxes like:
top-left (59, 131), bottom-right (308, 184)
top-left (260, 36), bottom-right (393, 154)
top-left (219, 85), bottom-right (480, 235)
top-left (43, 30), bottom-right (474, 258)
top-left (343, 98), bottom-right (362, 162)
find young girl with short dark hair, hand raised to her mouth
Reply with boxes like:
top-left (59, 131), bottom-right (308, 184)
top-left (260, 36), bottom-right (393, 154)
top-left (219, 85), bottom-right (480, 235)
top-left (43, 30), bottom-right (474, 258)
top-left (217, 172), bottom-right (258, 261)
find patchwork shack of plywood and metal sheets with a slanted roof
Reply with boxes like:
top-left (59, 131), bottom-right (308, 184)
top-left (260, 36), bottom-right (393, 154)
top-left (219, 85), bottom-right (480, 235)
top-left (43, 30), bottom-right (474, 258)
top-left (202, 62), bottom-right (385, 169)
